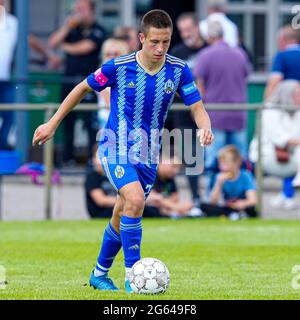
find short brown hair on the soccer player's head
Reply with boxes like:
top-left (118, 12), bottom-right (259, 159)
top-left (140, 9), bottom-right (173, 36)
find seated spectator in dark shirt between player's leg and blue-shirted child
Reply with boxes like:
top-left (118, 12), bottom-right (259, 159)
top-left (144, 158), bottom-right (202, 217)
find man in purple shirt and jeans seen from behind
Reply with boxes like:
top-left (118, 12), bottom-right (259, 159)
top-left (193, 21), bottom-right (250, 168)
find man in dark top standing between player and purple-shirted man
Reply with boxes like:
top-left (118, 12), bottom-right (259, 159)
top-left (167, 12), bottom-right (206, 206)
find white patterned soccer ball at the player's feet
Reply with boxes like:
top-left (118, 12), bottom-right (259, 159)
top-left (129, 258), bottom-right (170, 294)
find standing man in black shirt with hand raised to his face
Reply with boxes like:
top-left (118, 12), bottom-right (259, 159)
top-left (48, 0), bottom-right (105, 163)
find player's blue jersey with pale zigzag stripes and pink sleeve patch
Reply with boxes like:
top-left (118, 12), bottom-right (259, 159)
top-left (87, 52), bottom-right (201, 163)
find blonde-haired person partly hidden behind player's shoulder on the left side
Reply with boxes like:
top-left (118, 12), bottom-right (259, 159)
top-left (98, 38), bottom-right (130, 129)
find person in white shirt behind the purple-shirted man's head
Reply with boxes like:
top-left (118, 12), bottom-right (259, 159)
top-left (200, 0), bottom-right (239, 47)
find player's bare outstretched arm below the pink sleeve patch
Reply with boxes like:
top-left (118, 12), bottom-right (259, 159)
top-left (32, 80), bottom-right (93, 146)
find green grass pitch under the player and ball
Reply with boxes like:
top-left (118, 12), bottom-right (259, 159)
top-left (0, 219), bottom-right (300, 300)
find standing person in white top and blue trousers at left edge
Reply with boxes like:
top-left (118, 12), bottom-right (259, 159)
top-left (0, 0), bottom-right (18, 150)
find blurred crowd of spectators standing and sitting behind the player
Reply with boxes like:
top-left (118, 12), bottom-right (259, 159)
top-left (0, 0), bottom-right (300, 219)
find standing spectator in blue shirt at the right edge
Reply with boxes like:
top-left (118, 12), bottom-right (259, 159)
top-left (265, 25), bottom-right (300, 99)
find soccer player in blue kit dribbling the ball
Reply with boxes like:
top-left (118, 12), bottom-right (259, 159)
top-left (32, 10), bottom-right (213, 292)
